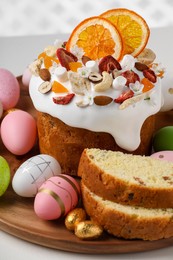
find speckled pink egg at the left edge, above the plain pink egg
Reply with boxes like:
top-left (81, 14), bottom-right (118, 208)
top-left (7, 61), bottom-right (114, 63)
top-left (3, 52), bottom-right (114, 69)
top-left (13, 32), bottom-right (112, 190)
top-left (0, 68), bottom-right (20, 110)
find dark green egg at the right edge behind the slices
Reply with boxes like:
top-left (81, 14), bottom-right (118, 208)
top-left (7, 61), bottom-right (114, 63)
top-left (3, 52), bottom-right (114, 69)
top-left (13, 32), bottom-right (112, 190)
top-left (153, 126), bottom-right (173, 152)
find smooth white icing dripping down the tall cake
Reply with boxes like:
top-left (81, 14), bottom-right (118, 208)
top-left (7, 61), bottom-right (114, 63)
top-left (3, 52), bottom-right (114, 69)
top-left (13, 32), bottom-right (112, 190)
top-left (29, 53), bottom-right (163, 151)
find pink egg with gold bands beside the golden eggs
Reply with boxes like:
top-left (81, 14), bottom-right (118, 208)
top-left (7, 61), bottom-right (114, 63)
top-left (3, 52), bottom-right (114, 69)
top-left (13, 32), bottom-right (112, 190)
top-left (34, 174), bottom-right (80, 220)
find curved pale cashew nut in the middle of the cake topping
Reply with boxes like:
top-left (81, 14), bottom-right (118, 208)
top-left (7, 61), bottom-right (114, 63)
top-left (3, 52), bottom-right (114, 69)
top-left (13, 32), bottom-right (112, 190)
top-left (94, 71), bottom-right (113, 92)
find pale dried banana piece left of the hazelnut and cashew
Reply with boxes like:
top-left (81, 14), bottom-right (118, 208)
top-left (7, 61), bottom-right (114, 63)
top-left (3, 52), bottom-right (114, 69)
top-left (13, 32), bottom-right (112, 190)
top-left (69, 72), bottom-right (91, 95)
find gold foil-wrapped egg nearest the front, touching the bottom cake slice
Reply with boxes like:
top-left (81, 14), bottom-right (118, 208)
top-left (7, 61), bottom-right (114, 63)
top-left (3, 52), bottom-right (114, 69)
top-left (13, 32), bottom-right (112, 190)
top-left (75, 220), bottom-right (103, 240)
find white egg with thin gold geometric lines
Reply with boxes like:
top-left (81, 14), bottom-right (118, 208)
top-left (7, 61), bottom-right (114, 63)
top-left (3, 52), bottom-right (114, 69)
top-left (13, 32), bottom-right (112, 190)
top-left (12, 154), bottom-right (61, 197)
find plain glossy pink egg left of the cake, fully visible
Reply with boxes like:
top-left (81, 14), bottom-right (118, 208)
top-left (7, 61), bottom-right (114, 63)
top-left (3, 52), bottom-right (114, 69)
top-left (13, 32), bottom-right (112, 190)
top-left (1, 110), bottom-right (37, 155)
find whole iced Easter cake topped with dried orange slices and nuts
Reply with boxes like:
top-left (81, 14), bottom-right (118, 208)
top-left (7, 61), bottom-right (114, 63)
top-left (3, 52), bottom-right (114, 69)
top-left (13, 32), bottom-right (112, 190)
top-left (29, 9), bottom-right (164, 175)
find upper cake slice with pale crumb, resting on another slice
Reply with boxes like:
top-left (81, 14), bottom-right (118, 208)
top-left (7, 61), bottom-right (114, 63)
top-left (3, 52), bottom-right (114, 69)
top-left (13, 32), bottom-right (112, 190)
top-left (78, 149), bottom-right (173, 208)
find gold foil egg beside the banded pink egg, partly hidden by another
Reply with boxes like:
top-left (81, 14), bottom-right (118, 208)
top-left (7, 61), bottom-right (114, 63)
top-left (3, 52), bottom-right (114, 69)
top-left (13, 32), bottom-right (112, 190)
top-left (65, 208), bottom-right (86, 230)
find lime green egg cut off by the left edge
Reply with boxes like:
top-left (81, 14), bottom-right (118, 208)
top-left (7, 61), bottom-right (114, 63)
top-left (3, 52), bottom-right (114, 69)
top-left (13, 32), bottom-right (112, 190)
top-left (0, 156), bottom-right (10, 196)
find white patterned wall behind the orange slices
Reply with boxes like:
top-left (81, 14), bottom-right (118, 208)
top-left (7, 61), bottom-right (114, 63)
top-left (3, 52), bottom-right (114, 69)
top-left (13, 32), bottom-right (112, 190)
top-left (0, 0), bottom-right (173, 36)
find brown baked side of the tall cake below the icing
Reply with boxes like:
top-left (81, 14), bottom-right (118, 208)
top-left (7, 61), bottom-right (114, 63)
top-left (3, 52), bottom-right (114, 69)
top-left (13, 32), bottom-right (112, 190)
top-left (37, 112), bottom-right (155, 175)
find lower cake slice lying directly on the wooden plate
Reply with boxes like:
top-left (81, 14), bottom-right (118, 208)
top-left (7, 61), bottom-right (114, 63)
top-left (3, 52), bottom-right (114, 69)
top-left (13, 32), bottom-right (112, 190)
top-left (81, 184), bottom-right (173, 240)
